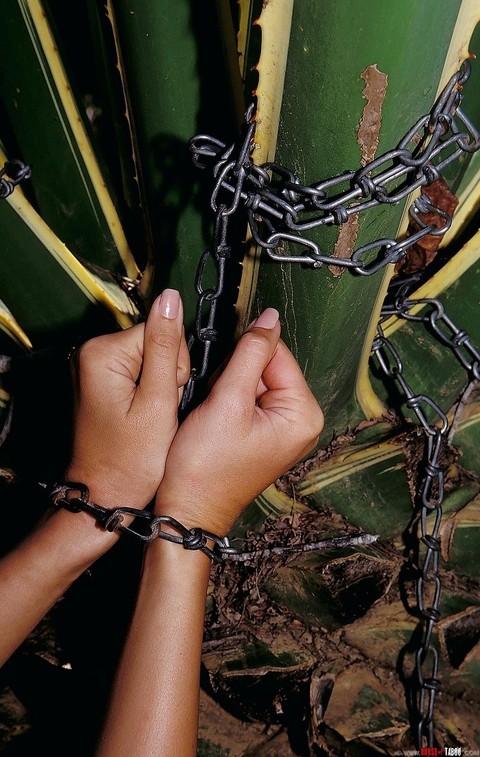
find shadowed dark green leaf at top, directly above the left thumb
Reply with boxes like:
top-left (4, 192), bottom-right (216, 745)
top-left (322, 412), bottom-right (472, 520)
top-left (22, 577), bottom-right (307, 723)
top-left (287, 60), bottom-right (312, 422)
top-left (108, 0), bottom-right (237, 322)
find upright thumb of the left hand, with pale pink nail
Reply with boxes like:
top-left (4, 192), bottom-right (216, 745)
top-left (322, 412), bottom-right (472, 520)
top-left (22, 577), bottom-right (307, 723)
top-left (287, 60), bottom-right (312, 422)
top-left (135, 289), bottom-right (185, 406)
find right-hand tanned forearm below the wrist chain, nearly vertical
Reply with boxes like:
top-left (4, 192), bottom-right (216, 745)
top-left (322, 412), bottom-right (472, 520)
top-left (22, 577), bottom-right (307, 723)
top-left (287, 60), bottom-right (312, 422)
top-left (97, 539), bottom-right (210, 757)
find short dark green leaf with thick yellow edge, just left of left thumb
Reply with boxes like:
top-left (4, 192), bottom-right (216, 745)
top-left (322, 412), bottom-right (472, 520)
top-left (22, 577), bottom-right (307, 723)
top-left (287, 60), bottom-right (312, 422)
top-left (0, 177), bottom-right (137, 348)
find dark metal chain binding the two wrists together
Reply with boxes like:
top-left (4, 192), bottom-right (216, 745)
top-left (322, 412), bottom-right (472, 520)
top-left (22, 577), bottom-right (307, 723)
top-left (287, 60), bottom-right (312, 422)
top-left (41, 481), bottom-right (237, 562)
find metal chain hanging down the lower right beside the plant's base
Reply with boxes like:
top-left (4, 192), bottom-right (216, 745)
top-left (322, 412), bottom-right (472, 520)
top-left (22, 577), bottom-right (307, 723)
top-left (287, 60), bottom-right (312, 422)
top-left (372, 294), bottom-right (480, 748)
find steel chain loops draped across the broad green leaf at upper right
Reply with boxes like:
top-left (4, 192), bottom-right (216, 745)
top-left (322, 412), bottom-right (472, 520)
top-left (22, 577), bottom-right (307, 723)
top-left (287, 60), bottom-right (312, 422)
top-left (190, 60), bottom-right (480, 276)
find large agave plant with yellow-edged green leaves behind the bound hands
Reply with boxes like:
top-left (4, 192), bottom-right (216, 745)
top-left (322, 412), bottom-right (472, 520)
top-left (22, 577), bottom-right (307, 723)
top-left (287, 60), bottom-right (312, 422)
top-left (0, 0), bottom-right (480, 757)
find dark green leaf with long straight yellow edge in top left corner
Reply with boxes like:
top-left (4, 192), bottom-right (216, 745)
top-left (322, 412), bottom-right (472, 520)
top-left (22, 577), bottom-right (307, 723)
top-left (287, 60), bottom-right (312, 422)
top-left (0, 0), bottom-right (138, 279)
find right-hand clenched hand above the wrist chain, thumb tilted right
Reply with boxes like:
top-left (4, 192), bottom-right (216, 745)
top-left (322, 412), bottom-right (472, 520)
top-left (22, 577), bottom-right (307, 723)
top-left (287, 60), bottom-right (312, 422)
top-left (155, 308), bottom-right (323, 536)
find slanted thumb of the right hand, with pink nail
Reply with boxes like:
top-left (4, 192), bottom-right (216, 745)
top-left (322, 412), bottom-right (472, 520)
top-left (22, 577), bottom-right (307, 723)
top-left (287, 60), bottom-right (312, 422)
top-left (212, 308), bottom-right (280, 401)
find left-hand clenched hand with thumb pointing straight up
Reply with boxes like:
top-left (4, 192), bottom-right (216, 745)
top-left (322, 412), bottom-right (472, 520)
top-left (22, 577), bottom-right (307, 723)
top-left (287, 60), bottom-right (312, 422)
top-left (67, 289), bottom-right (190, 508)
